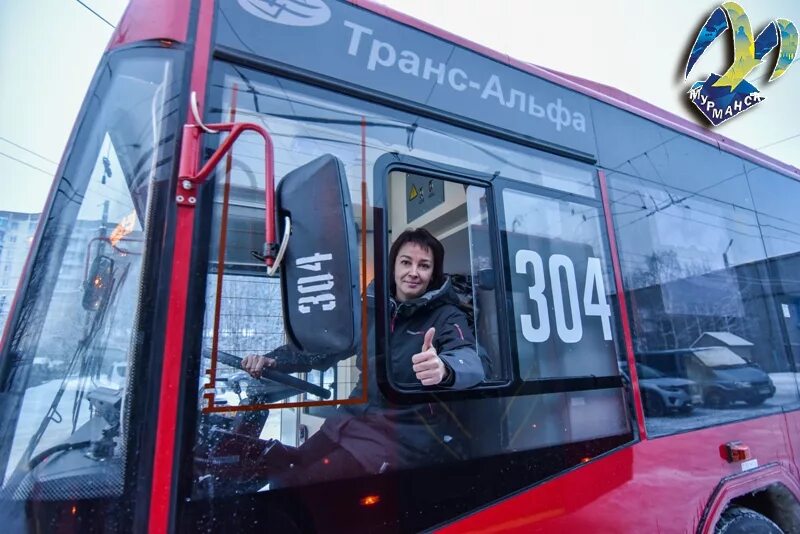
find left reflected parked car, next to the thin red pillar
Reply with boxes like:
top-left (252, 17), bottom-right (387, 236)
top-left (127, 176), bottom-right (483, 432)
top-left (621, 363), bottom-right (702, 417)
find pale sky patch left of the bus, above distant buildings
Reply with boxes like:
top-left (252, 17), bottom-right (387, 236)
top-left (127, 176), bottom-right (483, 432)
top-left (0, 0), bottom-right (125, 212)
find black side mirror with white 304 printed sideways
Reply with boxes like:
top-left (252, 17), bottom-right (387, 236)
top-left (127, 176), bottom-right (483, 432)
top-left (276, 155), bottom-right (361, 354)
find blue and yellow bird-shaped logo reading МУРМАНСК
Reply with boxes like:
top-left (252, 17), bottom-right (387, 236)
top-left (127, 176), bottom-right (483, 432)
top-left (685, 2), bottom-right (798, 126)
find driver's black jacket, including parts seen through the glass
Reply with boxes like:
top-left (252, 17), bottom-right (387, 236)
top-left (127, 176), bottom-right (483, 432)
top-left (269, 279), bottom-right (485, 473)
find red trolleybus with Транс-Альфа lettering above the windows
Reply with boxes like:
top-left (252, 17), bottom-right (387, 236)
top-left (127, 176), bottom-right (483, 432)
top-left (0, 0), bottom-right (800, 533)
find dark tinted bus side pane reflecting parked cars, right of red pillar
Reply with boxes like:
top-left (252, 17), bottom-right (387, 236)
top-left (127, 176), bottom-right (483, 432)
top-left (604, 146), bottom-right (797, 435)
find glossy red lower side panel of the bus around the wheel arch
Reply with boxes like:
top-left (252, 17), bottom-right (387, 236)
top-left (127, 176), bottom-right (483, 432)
top-left (442, 412), bottom-right (800, 533)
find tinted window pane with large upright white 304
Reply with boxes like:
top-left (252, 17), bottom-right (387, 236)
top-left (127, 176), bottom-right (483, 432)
top-left (502, 188), bottom-right (618, 380)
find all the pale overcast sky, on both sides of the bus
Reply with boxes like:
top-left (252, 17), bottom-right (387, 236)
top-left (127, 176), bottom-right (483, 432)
top-left (0, 0), bottom-right (800, 212)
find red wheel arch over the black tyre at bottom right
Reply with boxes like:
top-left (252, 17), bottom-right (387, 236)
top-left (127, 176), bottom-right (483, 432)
top-left (697, 464), bottom-right (800, 534)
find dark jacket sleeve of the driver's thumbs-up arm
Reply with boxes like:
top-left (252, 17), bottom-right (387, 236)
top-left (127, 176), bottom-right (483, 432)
top-left (433, 307), bottom-right (486, 389)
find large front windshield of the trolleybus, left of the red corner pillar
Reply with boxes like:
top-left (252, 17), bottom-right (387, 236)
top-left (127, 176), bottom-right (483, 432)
top-left (0, 48), bottom-right (179, 499)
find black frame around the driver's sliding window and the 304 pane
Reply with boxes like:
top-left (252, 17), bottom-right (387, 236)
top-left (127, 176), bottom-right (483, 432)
top-left (373, 153), bottom-right (624, 403)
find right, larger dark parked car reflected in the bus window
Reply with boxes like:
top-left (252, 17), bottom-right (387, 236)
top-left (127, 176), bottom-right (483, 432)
top-left (637, 347), bottom-right (775, 408)
